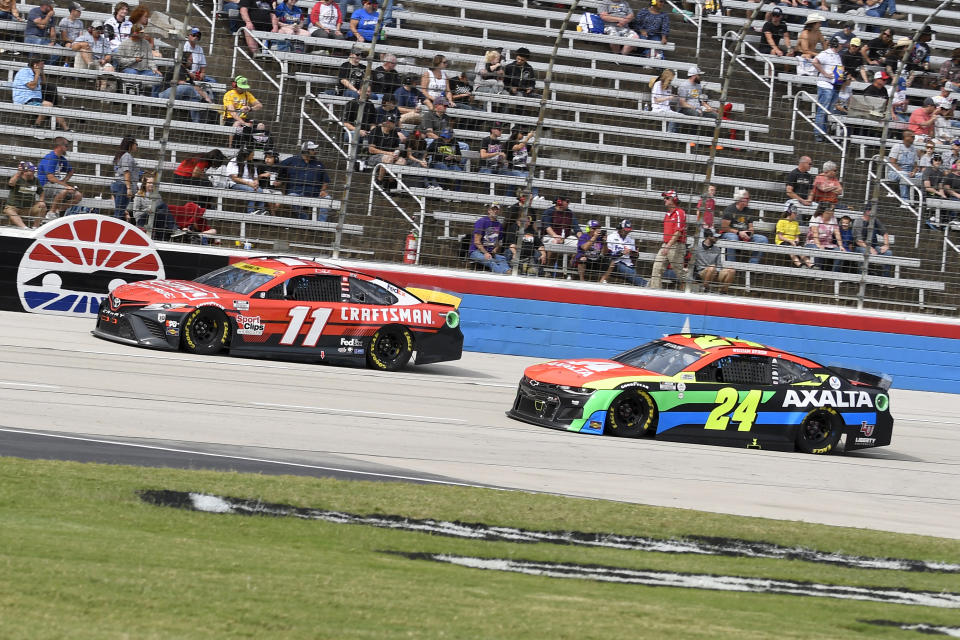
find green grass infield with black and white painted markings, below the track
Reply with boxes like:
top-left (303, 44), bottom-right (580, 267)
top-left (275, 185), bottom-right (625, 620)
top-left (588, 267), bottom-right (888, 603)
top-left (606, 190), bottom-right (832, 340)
top-left (0, 458), bottom-right (960, 639)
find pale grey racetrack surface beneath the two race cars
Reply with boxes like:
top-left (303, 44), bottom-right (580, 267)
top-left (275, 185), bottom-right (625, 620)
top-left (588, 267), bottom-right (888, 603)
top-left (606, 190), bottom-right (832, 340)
top-left (0, 312), bottom-right (960, 536)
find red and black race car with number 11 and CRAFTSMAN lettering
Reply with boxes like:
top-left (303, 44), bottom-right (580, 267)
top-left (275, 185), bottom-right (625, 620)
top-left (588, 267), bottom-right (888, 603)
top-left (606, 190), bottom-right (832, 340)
top-left (93, 257), bottom-right (463, 371)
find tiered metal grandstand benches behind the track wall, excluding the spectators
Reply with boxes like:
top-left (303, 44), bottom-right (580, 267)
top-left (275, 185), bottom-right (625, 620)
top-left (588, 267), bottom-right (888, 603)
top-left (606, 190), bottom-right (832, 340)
top-left (0, 0), bottom-right (960, 315)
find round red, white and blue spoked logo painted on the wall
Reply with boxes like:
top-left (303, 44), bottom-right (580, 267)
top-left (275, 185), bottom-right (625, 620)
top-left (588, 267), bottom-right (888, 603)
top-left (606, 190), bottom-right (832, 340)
top-left (17, 215), bottom-right (164, 317)
